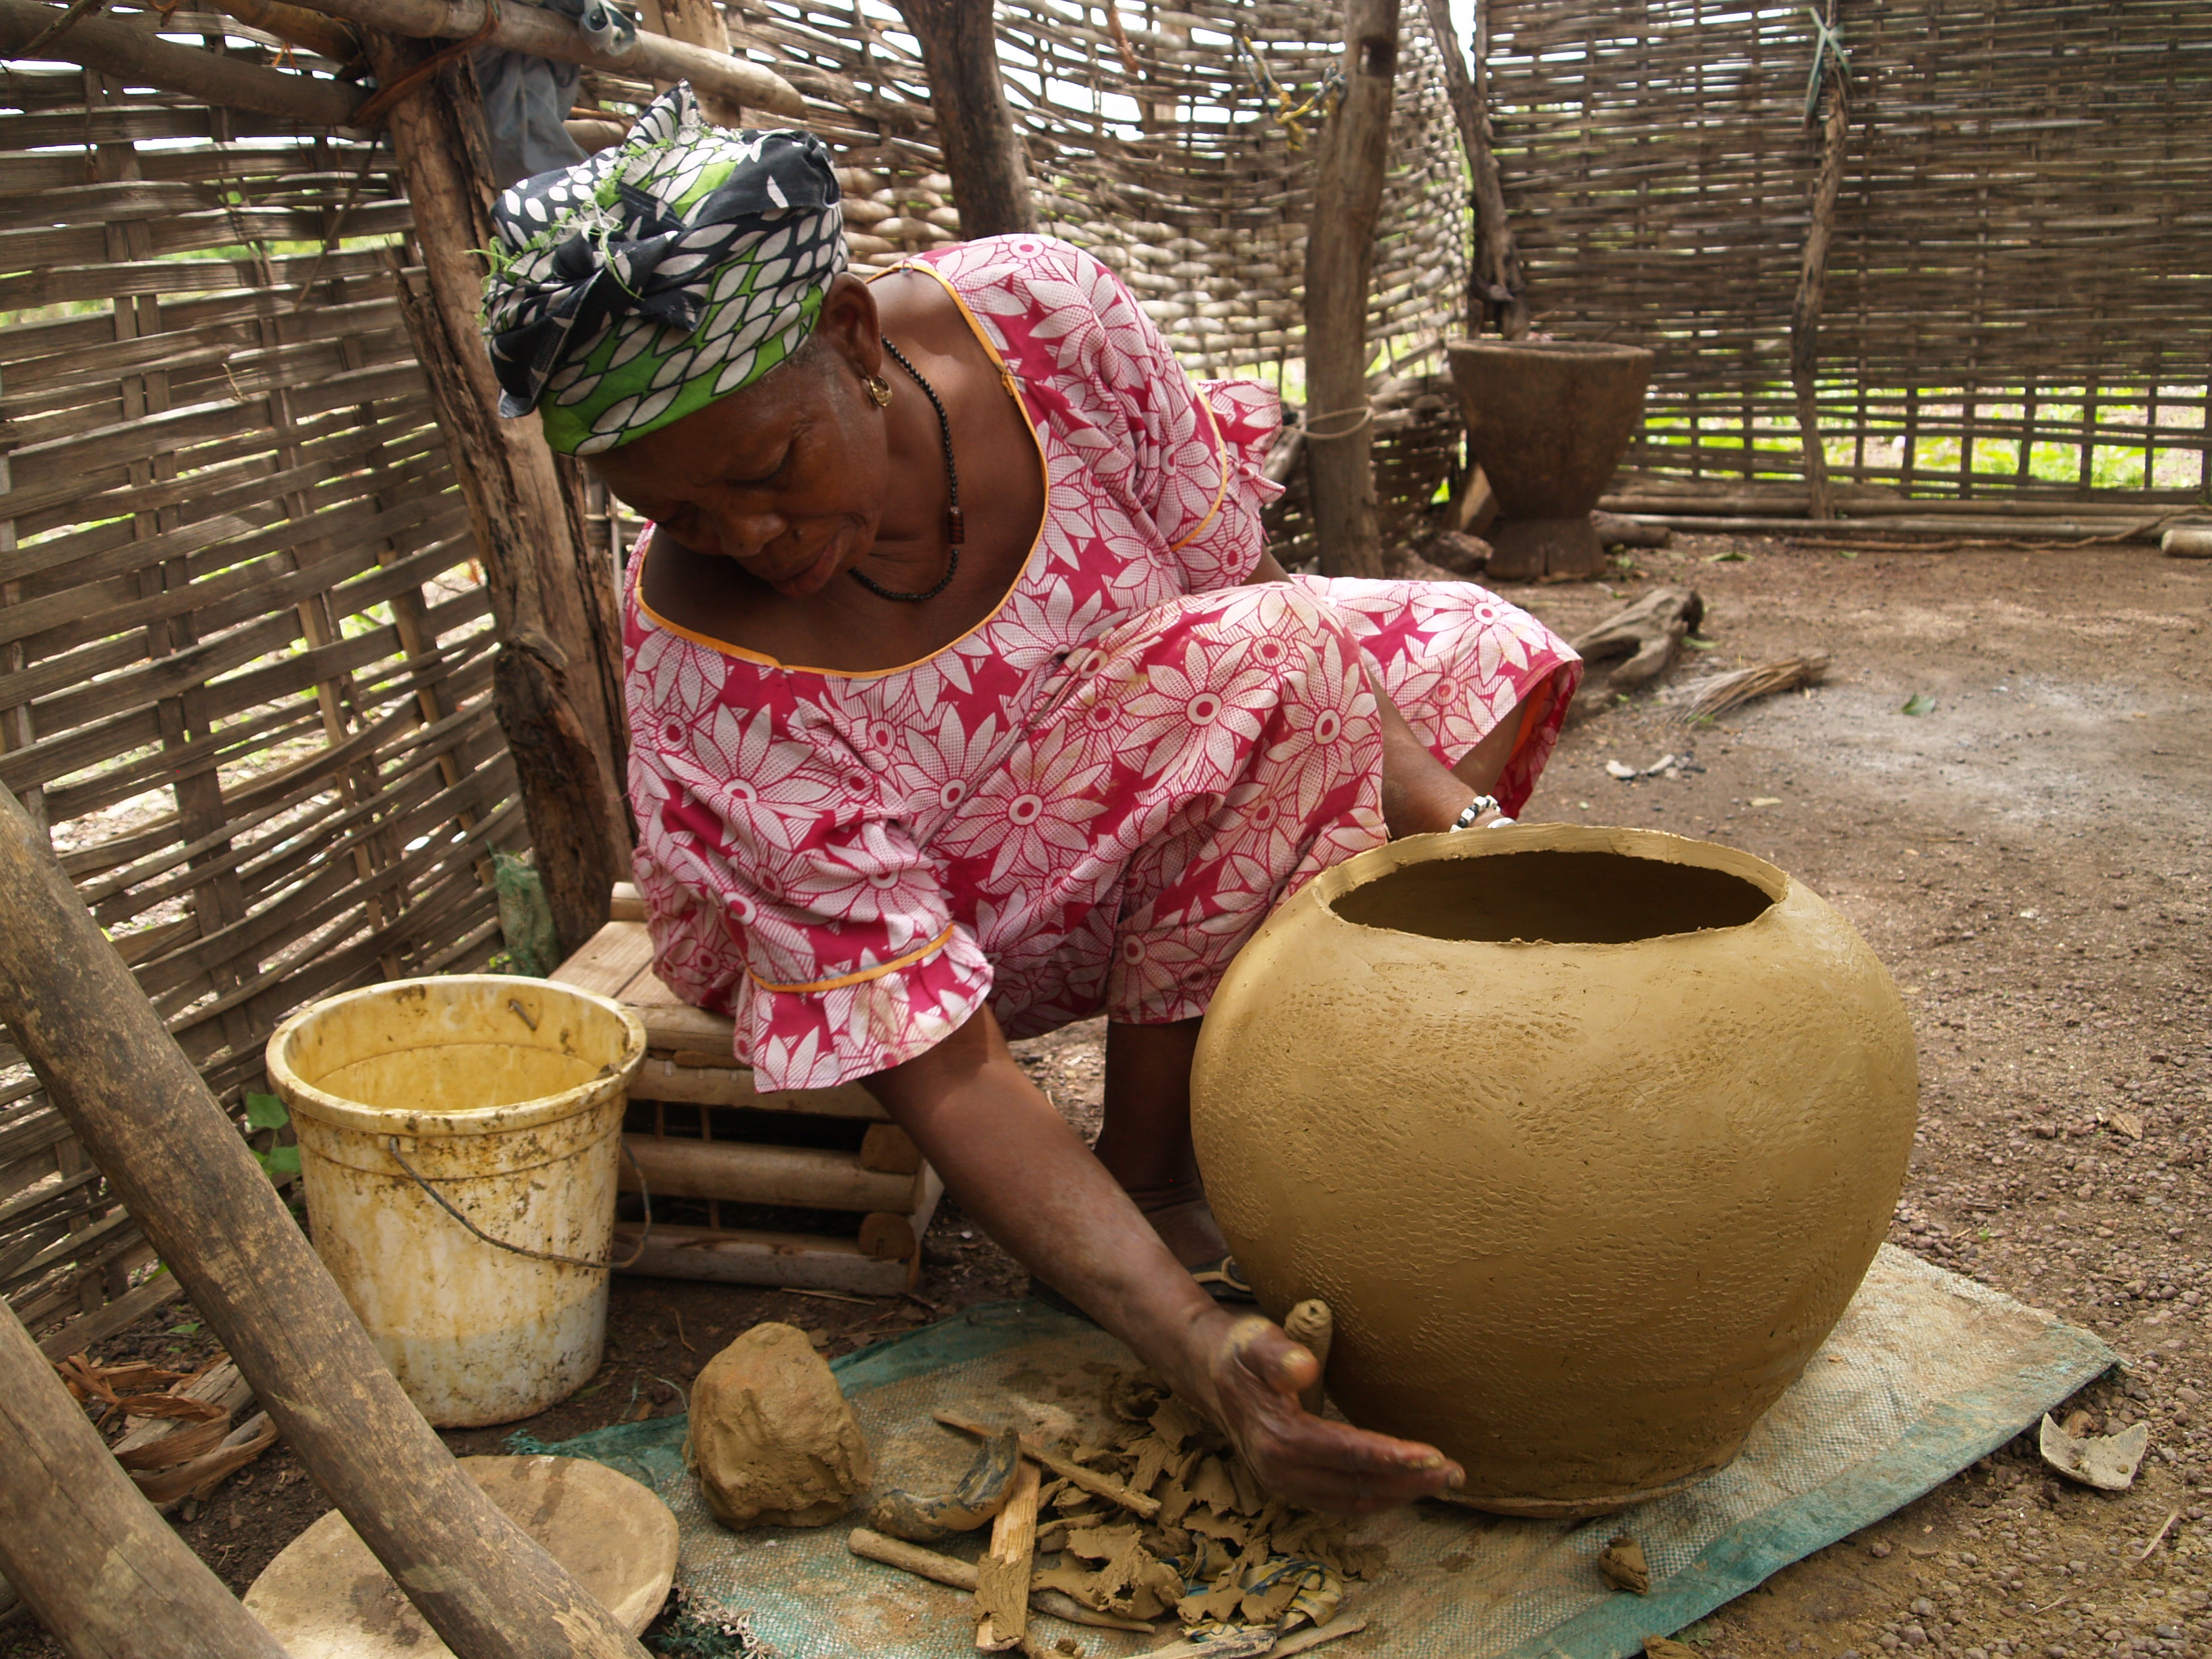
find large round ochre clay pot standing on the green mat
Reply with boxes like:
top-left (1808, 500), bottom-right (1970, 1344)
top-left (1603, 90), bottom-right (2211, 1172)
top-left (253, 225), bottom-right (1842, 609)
top-left (1192, 825), bottom-right (1920, 1515)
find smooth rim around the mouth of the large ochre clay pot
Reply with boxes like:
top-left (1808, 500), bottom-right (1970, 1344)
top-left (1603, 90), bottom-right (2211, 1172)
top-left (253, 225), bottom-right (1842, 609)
top-left (1298, 823), bottom-right (1796, 951)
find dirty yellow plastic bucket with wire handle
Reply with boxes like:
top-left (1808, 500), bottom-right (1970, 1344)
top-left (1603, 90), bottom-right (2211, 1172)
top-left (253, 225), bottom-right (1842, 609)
top-left (268, 973), bottom-right (646, 1427)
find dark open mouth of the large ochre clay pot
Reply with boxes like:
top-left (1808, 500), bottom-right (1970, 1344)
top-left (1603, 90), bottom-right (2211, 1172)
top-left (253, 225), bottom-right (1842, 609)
top-left (1330, 847), bottom-right (1781, 945)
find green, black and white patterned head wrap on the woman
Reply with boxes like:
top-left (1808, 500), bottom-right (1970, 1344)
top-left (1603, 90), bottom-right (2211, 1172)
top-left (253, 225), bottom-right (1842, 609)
top-left (485, 84), bottom-right (845, 455)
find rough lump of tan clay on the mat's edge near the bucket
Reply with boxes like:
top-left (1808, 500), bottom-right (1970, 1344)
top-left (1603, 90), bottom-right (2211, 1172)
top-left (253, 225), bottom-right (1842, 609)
top-left (684, 1325), bottom-right (874, 1526)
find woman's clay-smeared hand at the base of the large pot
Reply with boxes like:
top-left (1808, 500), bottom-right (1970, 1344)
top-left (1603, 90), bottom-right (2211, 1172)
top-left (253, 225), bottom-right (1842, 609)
top-left (1190, 1309), bottom-right (1467, 1515)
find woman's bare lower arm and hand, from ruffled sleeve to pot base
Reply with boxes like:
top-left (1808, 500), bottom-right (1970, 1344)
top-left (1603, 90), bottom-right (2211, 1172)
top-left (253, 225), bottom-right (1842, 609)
top-left (863, 1006), bottom-right (1460, 1515)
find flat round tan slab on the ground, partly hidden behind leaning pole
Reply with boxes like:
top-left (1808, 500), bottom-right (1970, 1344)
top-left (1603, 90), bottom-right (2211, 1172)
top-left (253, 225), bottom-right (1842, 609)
top-left (245, 1458), bottom-right (677, 1659)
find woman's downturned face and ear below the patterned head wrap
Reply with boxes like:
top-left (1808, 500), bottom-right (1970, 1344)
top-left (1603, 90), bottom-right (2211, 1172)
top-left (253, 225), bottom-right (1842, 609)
top-left (586, 276), bottom-right (889, 600)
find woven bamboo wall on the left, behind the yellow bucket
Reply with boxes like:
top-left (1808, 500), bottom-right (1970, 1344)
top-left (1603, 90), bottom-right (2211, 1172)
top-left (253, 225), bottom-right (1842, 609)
top-left (0, 32), bottom-right (522, 1353)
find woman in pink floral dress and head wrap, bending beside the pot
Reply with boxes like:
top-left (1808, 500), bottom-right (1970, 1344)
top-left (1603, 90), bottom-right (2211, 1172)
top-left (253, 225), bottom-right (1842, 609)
top-left (487, 86), bottom-right (1579, 1513)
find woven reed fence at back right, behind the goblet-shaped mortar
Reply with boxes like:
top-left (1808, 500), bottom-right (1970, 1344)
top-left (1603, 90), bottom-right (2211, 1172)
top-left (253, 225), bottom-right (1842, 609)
top-left (1484, 0), bottom-right (2212, 500)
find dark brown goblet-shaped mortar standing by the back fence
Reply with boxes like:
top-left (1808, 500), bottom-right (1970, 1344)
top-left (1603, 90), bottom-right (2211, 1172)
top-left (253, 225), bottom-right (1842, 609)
top-left (1447, 341), bottom-right (1652, 581)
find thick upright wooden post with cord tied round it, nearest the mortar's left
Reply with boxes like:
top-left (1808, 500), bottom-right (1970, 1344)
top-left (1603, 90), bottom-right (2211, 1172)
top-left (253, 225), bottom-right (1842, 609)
top-left (1305, 0), bottom-right (1398, 577)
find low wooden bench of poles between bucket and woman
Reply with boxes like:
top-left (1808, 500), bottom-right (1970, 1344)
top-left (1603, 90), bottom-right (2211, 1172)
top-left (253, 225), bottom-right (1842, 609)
top-left (553, 887), bottom-right (945, 1296)
